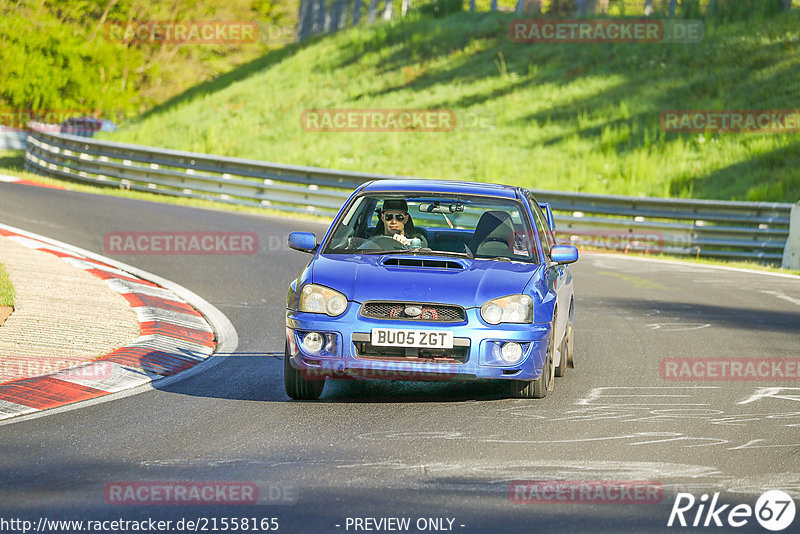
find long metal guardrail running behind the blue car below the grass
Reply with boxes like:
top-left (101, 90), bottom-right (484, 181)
top-left (25, 132), bottom-right (792, 263)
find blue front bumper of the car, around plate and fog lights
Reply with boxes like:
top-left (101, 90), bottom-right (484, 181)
top-left (286, 302), bottom-right (551, 380)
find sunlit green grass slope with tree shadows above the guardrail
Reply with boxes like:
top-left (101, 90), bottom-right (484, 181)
top-left (104, 11), bottom-right (800, 202)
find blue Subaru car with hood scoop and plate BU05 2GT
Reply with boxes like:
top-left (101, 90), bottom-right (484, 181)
top-left (284, 180), bottom-right (578, 400)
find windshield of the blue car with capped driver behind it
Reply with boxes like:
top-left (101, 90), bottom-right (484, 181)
top-left (323, 194), bottom-right (536, 262)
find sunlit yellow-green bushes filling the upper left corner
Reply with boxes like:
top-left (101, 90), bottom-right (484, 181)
top-left (0, 0), bottom-right (297, 120)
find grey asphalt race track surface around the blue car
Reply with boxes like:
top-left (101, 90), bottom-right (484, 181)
top-left (0, 184), bottom-right (800, 533)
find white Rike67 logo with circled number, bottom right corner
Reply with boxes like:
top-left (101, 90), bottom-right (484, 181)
top-left (667, 490), bottom-right (795, 532)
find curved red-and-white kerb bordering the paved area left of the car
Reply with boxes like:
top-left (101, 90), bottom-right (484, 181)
top-left (0, 228), bottom-right (217, 420)
